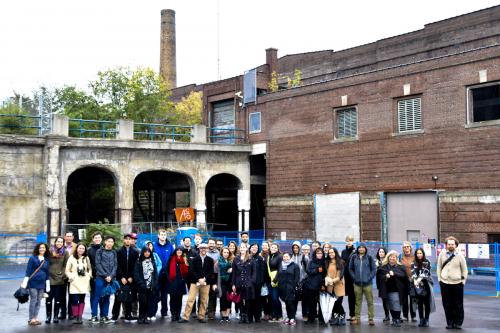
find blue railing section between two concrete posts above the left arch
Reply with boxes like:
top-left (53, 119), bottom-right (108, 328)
top-left (69, 119), bottom-right (118, 139)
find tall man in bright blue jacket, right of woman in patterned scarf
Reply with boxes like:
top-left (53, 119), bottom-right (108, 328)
top-left (154, 228), bottom-right (174, 317)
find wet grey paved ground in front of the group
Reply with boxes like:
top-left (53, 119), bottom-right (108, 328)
top-left (0, 280), bottom-right (500, 333)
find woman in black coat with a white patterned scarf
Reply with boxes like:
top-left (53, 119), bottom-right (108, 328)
top-left (134, 246), bottom-right (159, 324)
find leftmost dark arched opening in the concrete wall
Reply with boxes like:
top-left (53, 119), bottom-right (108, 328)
top-left (66, 167), bottom-right (115, 224)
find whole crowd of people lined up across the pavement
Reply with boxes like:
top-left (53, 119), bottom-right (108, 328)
top-left (21, 229), bottom-right (467, 329)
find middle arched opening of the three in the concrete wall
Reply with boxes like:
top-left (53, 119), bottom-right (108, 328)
top-left (134, 170), bottom-right (192, 223)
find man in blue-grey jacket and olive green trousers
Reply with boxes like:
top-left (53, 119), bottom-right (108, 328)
top-left (349, 243), bottom-right (377, 326)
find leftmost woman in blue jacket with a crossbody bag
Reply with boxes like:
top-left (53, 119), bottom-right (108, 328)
top-left (21, 243), bottom-right (50, 326)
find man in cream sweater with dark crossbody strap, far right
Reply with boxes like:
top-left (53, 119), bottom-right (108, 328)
top-left (436, 236), bottom-right (467, 329)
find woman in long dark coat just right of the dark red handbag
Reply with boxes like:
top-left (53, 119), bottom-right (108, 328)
top-left (232, 243), bottom-right (256, 324)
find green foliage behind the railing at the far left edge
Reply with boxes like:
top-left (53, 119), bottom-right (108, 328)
top-left (0, 103), bottom-right (38, 135)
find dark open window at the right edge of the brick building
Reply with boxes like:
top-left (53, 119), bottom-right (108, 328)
top-left (468, 82), bottom-right (500, 123)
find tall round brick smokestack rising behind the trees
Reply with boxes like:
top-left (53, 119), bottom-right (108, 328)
top-left (160, 9), bottom-right (177, 89)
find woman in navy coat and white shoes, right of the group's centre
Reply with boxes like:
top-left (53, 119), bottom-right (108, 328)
top-left (278, 252), bottom-right (300, 326)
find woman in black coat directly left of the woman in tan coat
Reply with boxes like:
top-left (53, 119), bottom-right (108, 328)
top-left (302, 248), bottom-right (326, 323)
